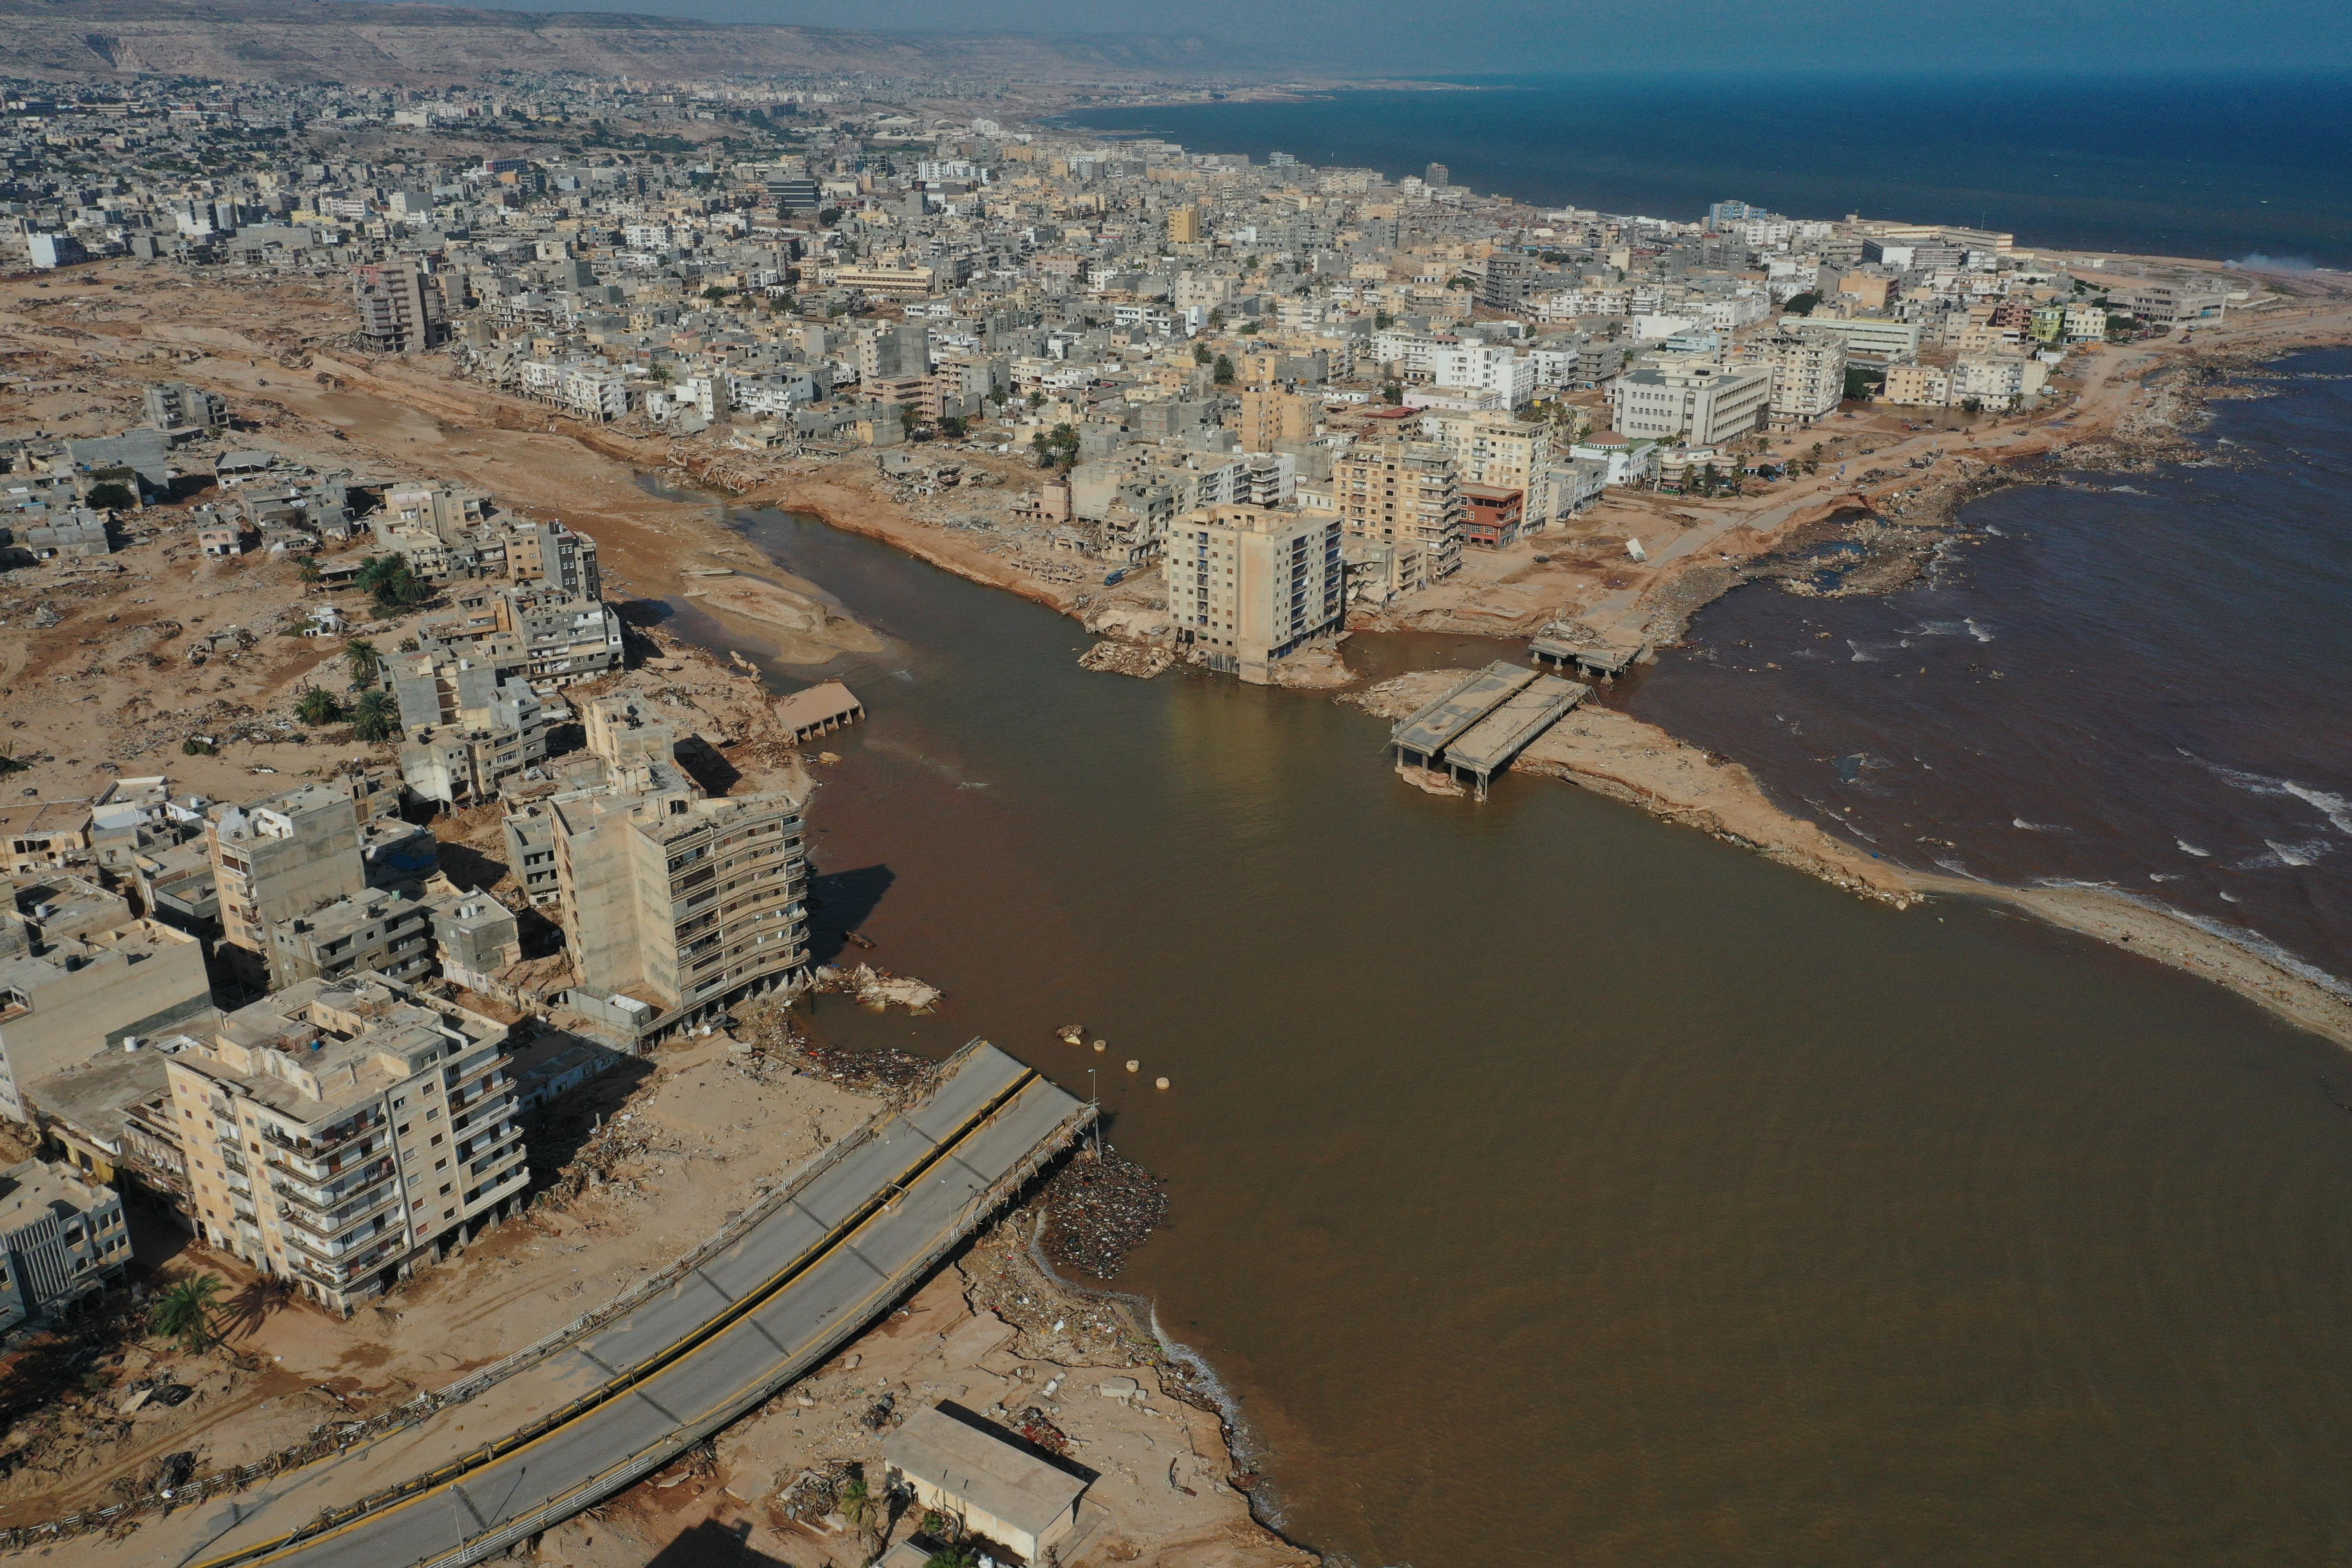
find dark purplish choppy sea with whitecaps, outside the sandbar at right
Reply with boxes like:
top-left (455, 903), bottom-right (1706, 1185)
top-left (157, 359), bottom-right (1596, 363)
top-left (1611, 350), bottom-right (2352, 994)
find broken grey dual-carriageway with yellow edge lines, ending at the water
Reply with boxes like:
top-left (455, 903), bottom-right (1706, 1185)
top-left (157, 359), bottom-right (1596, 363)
top-left (154, 1044), bottom-right (1089, 1568)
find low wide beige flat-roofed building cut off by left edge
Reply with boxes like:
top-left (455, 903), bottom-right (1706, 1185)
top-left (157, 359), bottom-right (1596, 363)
top-left (0, 919), bottom-right (211, 1121)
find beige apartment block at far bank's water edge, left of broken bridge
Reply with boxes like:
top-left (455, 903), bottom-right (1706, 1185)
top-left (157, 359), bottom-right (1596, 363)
top-left (1167, 505), bottom-right (1348, 686)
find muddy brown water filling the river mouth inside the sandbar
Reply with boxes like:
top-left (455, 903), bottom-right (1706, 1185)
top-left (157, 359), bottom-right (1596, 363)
top-left (649, 491), bottom-right (2352, 1568)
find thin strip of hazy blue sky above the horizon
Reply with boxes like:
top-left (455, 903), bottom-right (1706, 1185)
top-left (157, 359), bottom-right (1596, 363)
top-left (456, 0), bottom-right (2352, 73)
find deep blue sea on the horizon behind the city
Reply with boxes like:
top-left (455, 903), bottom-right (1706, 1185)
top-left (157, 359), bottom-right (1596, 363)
top-left (1068, 73), bottom-right (2352, 268)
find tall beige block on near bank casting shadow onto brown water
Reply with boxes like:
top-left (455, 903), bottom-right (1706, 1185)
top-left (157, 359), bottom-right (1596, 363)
top-left (546, 785), bottom-right (809, 1027)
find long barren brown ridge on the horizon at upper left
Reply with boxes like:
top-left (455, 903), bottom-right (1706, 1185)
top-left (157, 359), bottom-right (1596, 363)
top-left (0, 0), bottom-right (1242, 85)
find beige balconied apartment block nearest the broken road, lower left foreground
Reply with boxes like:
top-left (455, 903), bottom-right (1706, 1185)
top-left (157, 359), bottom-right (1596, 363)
top-left (165, 976), bottom-right (529, 1312)
